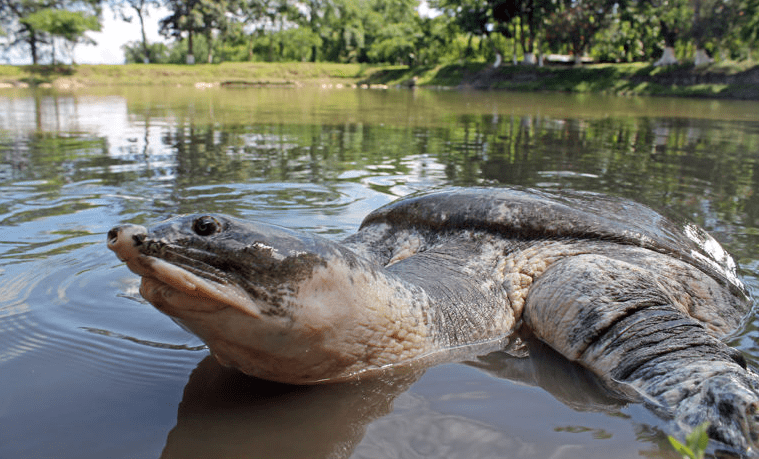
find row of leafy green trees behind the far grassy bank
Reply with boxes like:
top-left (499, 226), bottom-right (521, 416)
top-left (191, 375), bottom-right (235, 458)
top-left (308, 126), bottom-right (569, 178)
top-left (13, 0), bottom-right (748, 66)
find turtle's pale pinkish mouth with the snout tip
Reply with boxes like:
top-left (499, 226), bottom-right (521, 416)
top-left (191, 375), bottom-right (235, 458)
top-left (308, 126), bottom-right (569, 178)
top-left (108, 225), bottom-right (261, 318)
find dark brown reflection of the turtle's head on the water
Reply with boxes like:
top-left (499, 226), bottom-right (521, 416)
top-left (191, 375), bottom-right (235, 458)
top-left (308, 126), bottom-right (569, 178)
top-left (161, 357), bottom-right (420, 459)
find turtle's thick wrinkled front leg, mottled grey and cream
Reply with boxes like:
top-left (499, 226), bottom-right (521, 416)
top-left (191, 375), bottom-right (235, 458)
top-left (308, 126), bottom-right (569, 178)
top-left (523, 255), bottom-right (759, 454)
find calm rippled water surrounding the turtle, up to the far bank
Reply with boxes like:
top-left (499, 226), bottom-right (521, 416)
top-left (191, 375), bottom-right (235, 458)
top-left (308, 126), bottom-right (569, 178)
top-left (0, 88), bottom-right (759, 459)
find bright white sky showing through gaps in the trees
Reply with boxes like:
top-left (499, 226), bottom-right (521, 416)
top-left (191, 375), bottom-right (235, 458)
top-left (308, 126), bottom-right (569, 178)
top-left (7, 1), bottom-right (431, 65)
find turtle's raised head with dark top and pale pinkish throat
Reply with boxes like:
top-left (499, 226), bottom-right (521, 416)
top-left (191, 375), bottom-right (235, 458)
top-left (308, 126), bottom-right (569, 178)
top-left (108, 215), bottom-right (434, 383)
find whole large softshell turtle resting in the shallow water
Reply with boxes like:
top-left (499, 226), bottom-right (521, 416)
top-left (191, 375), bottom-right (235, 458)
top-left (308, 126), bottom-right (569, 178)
top-left (108, 188), bottom-right (759, 454)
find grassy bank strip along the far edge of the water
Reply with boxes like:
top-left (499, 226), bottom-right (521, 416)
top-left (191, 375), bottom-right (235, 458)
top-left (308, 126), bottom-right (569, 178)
top-left (0, 62), bottom-right (759, 100)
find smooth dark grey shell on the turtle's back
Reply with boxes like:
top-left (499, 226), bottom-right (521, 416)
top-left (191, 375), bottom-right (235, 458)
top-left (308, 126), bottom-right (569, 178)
top-left (361, 188), bottom-right (748, 298)
